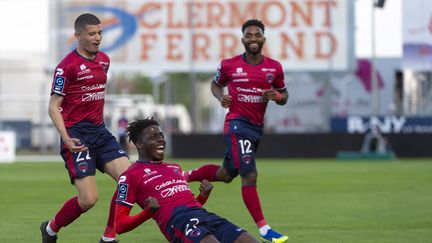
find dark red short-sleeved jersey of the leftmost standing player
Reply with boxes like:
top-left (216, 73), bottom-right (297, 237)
top-left (51, 50), bottom-right (110, 127)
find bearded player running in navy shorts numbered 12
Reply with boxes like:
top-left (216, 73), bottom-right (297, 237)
top-left (185, 19), bottom-right (288, 243)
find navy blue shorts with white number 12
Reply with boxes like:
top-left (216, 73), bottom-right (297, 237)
top-left (223, 120), bottom-right (262, 177)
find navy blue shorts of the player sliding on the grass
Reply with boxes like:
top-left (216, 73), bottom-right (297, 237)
top-left (164, 206), bottom-right (246, 243)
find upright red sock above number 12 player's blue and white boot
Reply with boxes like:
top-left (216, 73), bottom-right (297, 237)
top-left (242, 185), bottom-right (267, 228)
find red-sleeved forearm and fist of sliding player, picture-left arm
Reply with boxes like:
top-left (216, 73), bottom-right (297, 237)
top-left (115, 197), bottom-right (160, 234)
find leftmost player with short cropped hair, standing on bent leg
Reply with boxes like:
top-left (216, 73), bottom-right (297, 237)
top-left (40, 13), bottom-right (130, 243)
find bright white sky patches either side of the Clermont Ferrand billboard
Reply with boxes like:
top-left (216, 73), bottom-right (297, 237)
top-left (0, 0), bottom-right (402, 57)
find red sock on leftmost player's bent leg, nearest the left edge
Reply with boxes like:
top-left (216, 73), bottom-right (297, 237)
top-left (49, 197), bottom-right (84, 232)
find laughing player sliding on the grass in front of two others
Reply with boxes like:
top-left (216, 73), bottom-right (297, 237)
top-left (115, 118), bottom-right (259, 243)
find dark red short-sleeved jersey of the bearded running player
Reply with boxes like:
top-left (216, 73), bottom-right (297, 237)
top-left (213, 55), bottom-right (286, 126)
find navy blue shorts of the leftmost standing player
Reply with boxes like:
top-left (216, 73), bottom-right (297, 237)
top-left (60, 122), bottom-right (128, 184)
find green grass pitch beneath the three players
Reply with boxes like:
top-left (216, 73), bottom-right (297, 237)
top-left (0, 159), bottom-right (432, 243)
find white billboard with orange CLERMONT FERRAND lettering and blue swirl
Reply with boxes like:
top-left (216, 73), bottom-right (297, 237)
top-left (51, 0), bottom-right (354, 72)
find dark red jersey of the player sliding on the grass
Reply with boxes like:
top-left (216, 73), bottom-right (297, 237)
top-left (116, 161), bottom-right (201, 234)
